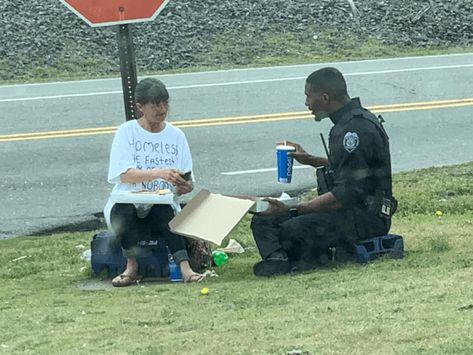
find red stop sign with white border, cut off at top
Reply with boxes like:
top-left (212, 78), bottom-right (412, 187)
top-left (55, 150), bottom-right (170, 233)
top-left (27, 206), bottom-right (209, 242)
top-left (61, 0), bottom-right (169, 27)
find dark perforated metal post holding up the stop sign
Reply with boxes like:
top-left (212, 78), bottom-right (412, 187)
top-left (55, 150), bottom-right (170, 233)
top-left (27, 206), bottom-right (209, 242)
top-left (117, 24), bottom-right (139, 121)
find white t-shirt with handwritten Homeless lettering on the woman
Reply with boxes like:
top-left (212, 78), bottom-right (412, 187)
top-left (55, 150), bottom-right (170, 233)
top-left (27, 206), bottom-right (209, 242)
top-left (104, 120), bottom-right (192, 228)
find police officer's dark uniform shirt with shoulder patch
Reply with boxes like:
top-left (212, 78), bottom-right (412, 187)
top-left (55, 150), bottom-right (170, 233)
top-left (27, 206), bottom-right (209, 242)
top-left (329, 98), bottom-right (392, 235)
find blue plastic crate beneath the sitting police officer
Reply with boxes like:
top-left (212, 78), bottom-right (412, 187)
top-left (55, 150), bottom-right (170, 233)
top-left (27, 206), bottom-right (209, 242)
top-left (354, 234), bottom-right (404, 264)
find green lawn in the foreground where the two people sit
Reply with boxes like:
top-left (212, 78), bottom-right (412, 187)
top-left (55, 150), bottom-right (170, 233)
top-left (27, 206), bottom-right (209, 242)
top-left (0, 163), bottom-right (473, 354)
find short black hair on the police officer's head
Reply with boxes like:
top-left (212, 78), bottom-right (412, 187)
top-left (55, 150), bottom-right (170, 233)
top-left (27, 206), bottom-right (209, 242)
top-left (306, 67), bottom-right (348, 100)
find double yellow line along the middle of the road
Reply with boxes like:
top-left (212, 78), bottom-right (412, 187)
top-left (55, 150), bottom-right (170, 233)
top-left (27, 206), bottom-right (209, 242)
top-left (0, 98), bottom-right (473, 142)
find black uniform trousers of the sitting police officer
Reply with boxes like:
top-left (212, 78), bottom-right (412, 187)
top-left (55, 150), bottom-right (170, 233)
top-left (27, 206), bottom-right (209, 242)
top-left (251, 210), bottom-right (387, 261)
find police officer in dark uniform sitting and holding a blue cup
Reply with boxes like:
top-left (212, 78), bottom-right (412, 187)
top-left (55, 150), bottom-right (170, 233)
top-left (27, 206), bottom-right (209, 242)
top-left (251, 68), bottom-right (396, 276)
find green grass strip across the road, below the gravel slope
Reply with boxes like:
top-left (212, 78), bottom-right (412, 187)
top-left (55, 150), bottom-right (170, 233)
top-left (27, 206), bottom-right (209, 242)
top-left (0, 26), bottom-right (473, 83)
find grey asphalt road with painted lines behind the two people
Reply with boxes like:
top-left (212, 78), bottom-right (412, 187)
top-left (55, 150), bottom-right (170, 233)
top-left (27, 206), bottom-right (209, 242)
top-left (0, 53), bottom-right (473, 238)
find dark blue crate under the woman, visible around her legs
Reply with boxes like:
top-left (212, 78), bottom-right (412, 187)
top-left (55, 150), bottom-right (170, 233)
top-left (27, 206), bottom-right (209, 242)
top-left (90, 231), bottom-right (169, 277)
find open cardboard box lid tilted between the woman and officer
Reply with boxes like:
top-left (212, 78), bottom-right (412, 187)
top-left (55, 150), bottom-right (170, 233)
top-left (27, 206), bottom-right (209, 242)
top-left (169, 189), bottom-right (255, 246)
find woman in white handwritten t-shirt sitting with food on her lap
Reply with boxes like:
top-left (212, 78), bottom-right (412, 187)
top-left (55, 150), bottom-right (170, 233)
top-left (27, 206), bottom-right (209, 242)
top-left (104, 78), bottom-right (204, 287)
